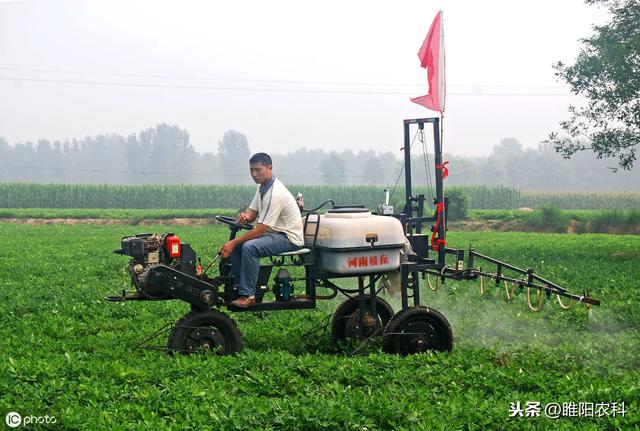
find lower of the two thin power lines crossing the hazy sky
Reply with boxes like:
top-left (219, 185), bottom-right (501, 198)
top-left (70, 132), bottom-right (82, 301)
top-left (0, 76), bottom-right (573, 97)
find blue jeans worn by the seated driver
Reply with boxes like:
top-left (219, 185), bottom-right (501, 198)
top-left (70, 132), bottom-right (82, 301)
top-left (231, 232), bottom-right (300, 296)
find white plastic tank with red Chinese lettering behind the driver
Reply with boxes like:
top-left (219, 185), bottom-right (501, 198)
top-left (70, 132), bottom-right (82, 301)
top-left (305, 208), bottom-right (405, 275)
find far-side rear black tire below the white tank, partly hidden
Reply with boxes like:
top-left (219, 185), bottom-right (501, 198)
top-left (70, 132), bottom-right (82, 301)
top-left (331, 295), bottom-right (393, 340)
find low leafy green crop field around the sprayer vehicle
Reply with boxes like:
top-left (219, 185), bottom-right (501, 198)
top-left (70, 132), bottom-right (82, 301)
top-left (0, 223), bottom-right (640, 430)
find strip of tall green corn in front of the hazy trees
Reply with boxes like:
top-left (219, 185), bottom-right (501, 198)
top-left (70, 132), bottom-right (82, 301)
top-left (0, 183), bottom-right (640, 209)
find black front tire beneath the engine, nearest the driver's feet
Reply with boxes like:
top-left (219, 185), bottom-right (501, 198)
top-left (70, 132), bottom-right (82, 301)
top-left (167, 310), bottom-right (244, 355)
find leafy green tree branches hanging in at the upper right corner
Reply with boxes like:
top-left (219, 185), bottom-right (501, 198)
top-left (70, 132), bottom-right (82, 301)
top-left (545, 0), bottom-right (640, 171)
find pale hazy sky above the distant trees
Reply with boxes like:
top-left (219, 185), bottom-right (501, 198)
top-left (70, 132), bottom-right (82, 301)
top-left (0, 0), bottom-right (606, 155)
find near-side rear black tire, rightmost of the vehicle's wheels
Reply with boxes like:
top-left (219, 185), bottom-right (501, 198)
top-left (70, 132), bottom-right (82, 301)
top-left (383, 306), bottom-right (453, 356)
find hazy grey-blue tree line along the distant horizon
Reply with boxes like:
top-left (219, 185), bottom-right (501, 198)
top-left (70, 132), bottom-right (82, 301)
top-left (0, 124), bottom-right (640, 191)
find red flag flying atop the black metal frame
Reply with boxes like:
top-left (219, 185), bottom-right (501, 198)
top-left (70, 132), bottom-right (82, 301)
top-left (411, 11), bottom-right (447, 113)
